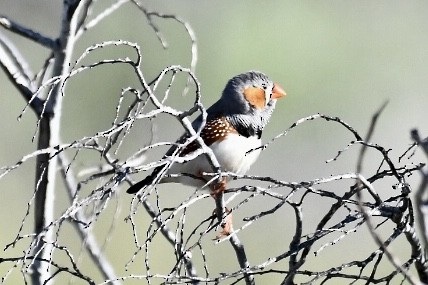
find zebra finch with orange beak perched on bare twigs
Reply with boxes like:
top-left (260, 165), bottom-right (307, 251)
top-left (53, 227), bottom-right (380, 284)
top-left (127, 71), bottom-right (286, 198)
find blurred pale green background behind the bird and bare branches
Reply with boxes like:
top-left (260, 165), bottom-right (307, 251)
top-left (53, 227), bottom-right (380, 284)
top-left (0, 0), bottom-right (428, 284)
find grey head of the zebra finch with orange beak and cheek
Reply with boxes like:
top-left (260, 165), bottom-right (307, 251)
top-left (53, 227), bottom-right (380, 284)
top-left (208, 71), bottom-right (285, 136)
